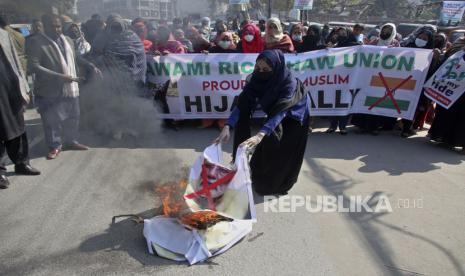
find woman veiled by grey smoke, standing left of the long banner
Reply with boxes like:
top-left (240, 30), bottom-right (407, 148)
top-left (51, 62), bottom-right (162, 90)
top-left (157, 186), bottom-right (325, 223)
top-left (87, 14), bottom-right (147, 140)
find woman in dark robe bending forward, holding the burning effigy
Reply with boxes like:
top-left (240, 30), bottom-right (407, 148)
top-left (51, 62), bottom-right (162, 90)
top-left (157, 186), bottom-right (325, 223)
top-left (215, 50), bottom-right (310, 195)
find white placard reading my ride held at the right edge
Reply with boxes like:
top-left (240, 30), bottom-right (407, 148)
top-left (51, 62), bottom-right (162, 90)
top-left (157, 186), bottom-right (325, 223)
top-left (425, 50), bottom-right (465, 109)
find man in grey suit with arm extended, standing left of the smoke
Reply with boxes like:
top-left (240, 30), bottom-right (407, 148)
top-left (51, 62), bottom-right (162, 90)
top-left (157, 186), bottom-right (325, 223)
top-left (28, 15), bottom-right (101, 159)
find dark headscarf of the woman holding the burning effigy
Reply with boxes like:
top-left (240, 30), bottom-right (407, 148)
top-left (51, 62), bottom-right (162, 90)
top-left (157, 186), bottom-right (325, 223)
top-left (243, 50), bottom-right (297, 115)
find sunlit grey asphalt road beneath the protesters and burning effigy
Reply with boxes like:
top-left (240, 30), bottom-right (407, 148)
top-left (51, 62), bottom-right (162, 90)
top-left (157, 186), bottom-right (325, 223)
top-left (0, 111), bottom-right (465, 275)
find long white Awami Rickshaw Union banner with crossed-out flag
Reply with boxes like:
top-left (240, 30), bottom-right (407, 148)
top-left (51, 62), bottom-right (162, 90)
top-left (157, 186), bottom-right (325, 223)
top-left (148, 46), bottom-right (432, 119)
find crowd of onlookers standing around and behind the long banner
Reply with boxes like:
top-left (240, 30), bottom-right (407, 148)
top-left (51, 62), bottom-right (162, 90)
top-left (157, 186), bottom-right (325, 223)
top-left (0, 14), bottom-right (465, 190)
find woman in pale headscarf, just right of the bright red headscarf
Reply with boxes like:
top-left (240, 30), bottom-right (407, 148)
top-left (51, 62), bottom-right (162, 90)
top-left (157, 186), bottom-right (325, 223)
top-left (265, 18), bottom-right (295, 53)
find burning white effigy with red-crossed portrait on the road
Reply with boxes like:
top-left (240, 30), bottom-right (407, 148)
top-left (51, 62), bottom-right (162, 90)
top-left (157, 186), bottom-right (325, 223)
top-left (143, 145), bottom-right (256, 265)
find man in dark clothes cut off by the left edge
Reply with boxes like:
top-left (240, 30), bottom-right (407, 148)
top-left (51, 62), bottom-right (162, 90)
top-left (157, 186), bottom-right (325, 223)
top-left (0, 25), bottom-right (40, 189)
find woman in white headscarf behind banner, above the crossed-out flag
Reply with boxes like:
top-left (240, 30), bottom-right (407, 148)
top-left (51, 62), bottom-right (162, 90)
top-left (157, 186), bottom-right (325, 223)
top-left (351, 23), bottom-right (400, 135)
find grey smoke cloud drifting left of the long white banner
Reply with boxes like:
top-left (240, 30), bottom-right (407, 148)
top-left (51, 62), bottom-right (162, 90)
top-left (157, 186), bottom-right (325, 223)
top-left (81, 54), bottom-right (161, 140)
